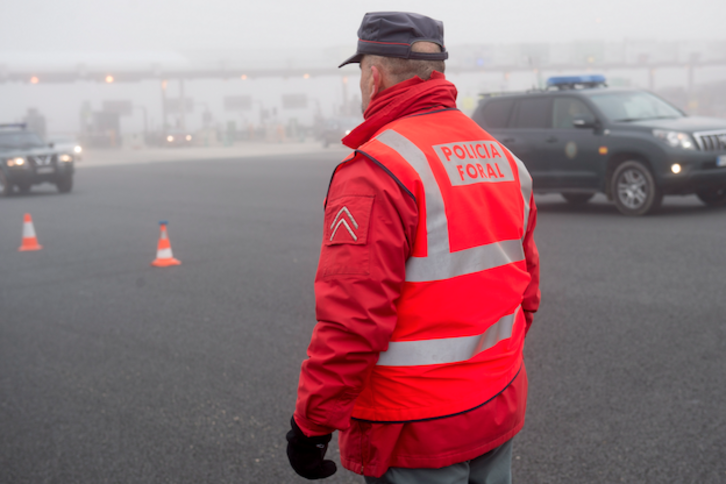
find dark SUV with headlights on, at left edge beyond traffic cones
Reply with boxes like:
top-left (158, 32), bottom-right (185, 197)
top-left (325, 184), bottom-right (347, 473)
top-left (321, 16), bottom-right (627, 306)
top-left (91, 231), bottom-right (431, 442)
top-left (0, 124), bottom-right (74, 196)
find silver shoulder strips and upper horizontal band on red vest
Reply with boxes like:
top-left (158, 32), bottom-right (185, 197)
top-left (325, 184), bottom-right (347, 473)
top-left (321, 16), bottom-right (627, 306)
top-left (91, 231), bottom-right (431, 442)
top-left (376, 130), bottom-right (532, 282)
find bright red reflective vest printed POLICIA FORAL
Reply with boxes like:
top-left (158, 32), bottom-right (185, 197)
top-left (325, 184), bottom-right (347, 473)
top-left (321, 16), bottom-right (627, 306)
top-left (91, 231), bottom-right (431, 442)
top-left (352, 110), bottom-right (532, 422)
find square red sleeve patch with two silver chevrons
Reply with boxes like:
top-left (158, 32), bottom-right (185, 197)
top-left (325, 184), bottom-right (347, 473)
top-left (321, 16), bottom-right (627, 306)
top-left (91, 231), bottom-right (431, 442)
top-left (323, 195), bottom-right (374, 245)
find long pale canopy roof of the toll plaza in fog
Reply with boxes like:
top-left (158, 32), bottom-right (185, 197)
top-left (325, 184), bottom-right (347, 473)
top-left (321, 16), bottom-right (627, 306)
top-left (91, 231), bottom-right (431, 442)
top-left (0, 40), bottom-right (726, 89)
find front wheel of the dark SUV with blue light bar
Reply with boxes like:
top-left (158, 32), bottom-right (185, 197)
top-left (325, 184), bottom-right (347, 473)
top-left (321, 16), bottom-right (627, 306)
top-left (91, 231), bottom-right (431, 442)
top-left (611, 160), bottom-right (663, 216)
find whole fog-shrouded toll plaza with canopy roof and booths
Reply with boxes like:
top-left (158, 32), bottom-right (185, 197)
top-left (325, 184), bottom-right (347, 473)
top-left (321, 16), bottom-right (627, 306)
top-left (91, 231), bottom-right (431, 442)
top-left (0, 40), bottom-right (726, 147)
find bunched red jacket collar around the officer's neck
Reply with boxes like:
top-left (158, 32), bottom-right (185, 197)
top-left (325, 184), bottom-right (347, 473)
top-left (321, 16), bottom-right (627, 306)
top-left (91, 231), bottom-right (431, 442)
top-left (343, 71), bottom-right (457, 149)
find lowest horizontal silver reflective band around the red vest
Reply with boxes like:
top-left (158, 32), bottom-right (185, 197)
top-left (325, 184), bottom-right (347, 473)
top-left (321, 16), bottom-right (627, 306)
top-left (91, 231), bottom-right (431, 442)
top-left (378, 308), bottom-right (519, 366)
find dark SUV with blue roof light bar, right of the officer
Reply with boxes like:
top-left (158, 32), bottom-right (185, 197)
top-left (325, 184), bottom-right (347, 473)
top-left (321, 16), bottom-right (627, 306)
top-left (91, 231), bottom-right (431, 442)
top-left (472, 76), bottom-right (726, 215)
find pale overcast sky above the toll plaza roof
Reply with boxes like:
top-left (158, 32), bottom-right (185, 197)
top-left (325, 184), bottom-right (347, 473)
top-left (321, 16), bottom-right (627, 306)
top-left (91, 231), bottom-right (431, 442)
top-left (0, 0), bottom-right (726, 52)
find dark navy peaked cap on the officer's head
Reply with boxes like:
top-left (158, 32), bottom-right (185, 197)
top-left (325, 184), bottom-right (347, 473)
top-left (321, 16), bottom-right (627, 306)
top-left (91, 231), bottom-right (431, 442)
top-left (338, 12), bottom-right (449, 67)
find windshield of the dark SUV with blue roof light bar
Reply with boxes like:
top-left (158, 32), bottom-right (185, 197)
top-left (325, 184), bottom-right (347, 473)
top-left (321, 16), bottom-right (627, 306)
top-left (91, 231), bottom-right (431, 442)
top-left (590, 91), bottom-right (684, 122)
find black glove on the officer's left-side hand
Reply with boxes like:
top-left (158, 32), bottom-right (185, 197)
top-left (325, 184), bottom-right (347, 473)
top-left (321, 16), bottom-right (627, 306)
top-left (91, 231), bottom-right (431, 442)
top-left (287, 418), bottom-right (338, 479)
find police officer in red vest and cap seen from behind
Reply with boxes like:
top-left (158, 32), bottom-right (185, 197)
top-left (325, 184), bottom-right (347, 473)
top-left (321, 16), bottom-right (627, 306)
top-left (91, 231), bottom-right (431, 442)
top-left (287, 12), bottom-right (540, 484)
